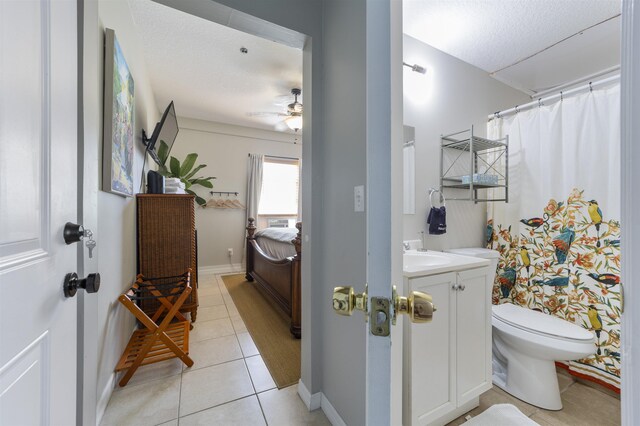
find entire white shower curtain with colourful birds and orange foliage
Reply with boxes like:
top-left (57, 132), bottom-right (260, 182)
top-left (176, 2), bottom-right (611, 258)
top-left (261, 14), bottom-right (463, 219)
top-left (487, 85), bottom-right (622, 391)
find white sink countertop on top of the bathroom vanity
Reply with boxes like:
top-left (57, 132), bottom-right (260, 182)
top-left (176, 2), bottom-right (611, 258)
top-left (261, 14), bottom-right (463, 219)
top-left (402, 250), bottom-right (488, 277)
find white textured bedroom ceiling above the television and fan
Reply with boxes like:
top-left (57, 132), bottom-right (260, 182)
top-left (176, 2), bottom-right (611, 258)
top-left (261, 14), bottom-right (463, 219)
top-left (129, 0), bottom-right (302, 131)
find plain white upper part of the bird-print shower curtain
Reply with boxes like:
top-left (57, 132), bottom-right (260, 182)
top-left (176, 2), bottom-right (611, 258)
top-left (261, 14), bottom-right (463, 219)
top-left (487, 85), bottom-right (620, 226)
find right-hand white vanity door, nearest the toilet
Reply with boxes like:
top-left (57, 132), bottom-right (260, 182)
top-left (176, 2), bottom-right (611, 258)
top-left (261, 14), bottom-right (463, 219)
top-left (455, 268), bottom-right (492, 405)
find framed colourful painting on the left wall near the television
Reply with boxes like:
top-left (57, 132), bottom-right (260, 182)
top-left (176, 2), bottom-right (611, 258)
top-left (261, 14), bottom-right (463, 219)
top-left (102, 28), bottom-right (135, 197)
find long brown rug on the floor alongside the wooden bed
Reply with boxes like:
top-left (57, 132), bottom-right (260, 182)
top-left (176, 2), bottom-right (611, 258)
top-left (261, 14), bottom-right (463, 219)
top-left (222, 274), bottom-right (300, 389)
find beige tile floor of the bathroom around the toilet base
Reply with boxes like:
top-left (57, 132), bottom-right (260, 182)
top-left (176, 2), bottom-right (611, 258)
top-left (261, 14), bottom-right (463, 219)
top-left (448, 374), bottom-right (620, 426)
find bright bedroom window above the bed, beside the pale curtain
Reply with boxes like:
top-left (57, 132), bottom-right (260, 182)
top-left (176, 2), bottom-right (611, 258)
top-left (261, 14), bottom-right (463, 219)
top-left (258, 156), bottom-right (300, 217)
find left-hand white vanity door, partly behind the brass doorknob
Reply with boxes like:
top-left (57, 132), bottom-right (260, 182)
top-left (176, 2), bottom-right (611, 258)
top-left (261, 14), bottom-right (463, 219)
top-left (405, 273), bottom-right (456, 425)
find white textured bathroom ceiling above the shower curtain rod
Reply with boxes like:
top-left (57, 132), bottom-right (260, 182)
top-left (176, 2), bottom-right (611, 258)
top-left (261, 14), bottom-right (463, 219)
top-left (403, 0), bottom-right (620, 92)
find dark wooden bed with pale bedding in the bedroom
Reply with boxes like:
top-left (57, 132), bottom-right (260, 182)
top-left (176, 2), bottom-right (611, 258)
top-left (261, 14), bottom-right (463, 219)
top-left (246, 217), bottom-right (302, 339)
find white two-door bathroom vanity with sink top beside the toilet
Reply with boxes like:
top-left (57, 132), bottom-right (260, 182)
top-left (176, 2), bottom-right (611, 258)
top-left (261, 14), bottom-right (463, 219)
top-left (403, 251), bottom-right (492, 425)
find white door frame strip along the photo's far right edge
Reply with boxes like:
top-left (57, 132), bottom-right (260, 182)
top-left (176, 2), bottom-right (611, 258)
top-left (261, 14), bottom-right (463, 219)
top-left (620, 0), bottom-right (640, 426)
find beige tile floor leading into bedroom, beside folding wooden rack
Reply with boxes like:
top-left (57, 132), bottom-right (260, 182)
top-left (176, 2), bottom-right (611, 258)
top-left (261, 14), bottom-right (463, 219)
top-left (101, 275), bottom-right (330, 426)
